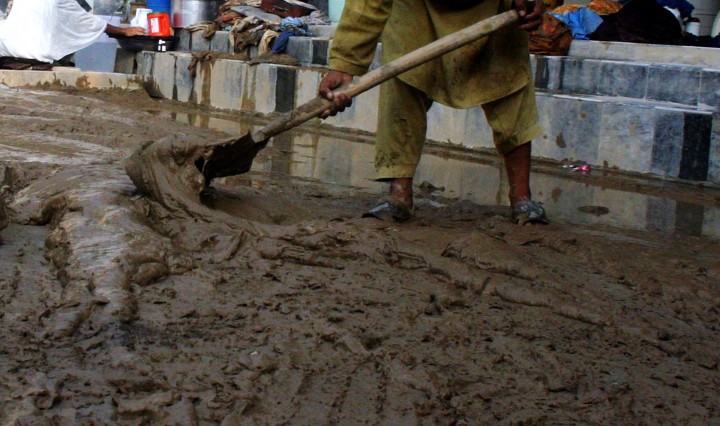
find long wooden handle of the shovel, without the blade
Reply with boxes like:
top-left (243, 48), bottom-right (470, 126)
top-left (252, 10), bottom-right (519, 143)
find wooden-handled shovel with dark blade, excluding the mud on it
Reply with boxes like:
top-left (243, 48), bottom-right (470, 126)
top-left (198, 10), bottom-right (518, 182)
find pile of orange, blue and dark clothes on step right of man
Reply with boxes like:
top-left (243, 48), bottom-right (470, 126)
top-left (530, 0), bottom-right (720, 55)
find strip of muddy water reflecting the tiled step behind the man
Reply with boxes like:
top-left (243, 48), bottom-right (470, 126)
top-left (163, 112), bottom-right (720, 238)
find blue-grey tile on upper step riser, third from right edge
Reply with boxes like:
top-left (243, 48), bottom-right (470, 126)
top-left (597, 61), bottom-right (648, 99)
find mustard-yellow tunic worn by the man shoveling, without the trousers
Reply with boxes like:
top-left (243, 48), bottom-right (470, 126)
top-left (330, 0), bottom-right (532, 108)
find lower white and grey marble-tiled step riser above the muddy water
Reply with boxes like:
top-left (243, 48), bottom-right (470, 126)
top-left (138, 52), bottom-right (720, 183)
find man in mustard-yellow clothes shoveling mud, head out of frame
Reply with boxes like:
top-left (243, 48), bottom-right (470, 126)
top-left (320, 0), bottom-right (548, 224)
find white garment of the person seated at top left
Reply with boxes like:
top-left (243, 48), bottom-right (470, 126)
top-left (0, 0), bottom-right (107, 62)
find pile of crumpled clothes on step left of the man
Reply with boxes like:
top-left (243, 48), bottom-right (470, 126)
top-left (185, 0), bottom-right (329, 55)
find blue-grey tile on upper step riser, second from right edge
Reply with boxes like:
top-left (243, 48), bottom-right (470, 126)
top-left (647, 65), bottom-right (700, 105)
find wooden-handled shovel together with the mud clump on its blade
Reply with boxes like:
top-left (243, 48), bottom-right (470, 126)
top-left (125, 10), bottom-right (518, 215)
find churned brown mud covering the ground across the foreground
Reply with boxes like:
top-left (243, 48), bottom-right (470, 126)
top-left (0, 85), bottom-right (720, 425)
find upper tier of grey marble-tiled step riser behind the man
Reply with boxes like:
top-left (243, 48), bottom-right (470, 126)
top-left (174, 26), bottom-right (720, 111)
